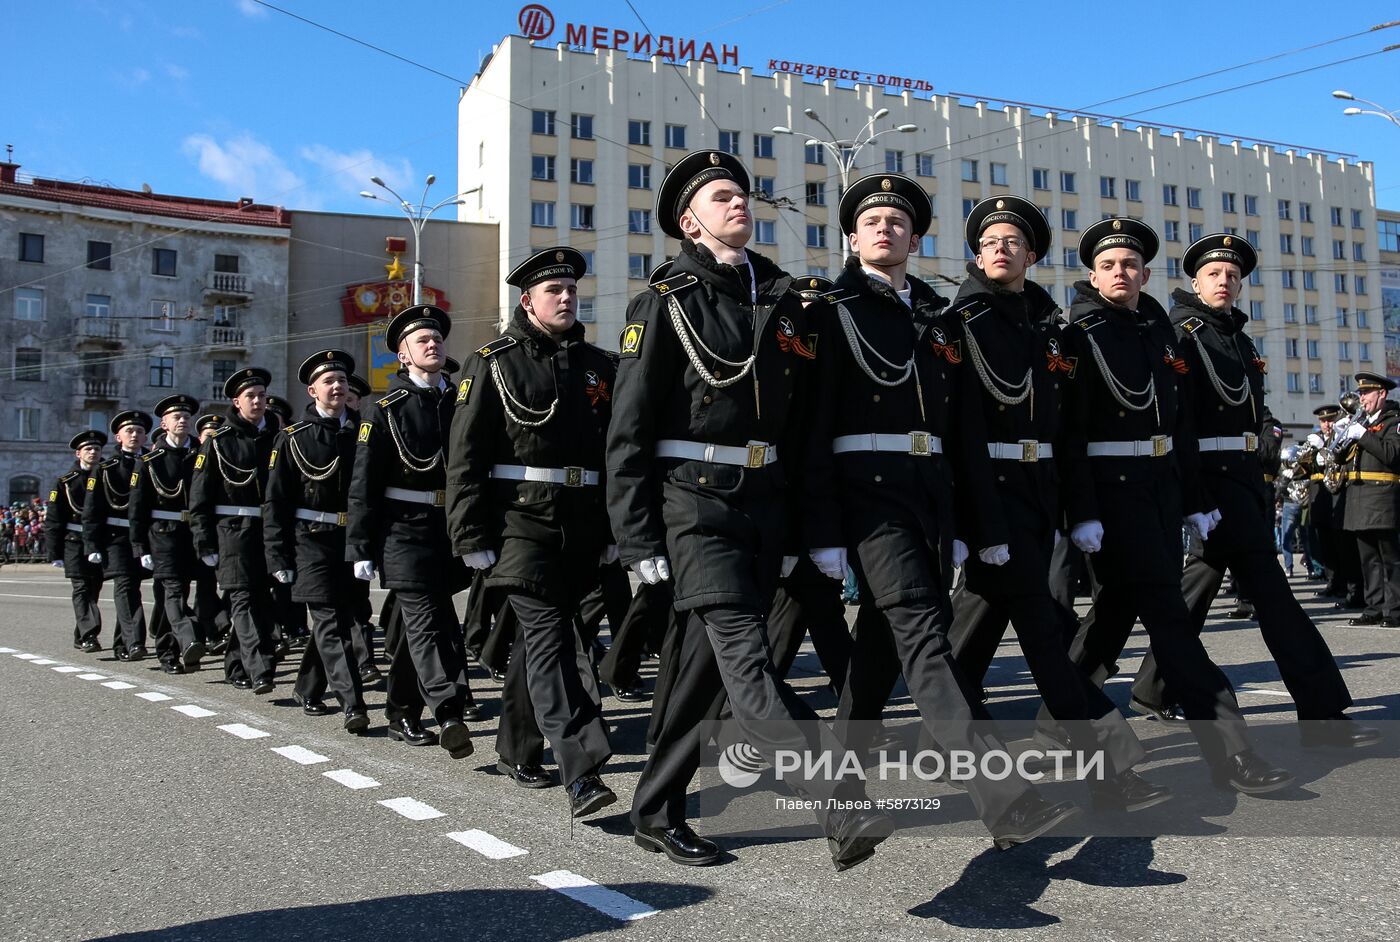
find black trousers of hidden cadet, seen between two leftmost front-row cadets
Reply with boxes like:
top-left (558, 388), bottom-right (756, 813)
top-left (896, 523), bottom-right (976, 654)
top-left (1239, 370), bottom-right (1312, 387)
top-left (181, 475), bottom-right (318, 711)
top-left (769, 556), bottom-right (851, 696)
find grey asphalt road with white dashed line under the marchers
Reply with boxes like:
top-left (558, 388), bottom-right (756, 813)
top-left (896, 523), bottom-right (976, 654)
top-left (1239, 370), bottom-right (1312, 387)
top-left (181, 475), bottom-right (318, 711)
top-left (0, 567), bottom-right (1400, 942)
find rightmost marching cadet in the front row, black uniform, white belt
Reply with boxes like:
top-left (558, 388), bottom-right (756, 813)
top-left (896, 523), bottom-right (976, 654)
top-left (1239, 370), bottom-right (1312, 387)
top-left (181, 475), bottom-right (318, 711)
top-left (1133, 232), bottom-right (1377, 746)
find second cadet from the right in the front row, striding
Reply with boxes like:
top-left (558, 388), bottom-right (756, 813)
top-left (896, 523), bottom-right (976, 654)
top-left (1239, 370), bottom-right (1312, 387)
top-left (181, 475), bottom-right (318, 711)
top-left (1056, 217), bottom-right (1294, 795)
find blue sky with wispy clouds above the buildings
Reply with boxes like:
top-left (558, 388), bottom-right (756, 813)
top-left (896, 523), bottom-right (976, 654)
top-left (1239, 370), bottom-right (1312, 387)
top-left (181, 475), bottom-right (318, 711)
top-left (10, 0), bottom-right (1400, 213)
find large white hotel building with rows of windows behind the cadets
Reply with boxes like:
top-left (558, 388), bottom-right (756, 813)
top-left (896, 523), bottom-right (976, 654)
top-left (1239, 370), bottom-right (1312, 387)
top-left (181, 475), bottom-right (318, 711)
top-left (458, 36), bottom-right (1386, 428)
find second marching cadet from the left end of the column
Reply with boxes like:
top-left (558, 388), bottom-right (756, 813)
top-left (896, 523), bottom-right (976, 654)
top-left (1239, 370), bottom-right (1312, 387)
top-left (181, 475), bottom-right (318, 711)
top-left (83, 409), bottom-right (153, 661)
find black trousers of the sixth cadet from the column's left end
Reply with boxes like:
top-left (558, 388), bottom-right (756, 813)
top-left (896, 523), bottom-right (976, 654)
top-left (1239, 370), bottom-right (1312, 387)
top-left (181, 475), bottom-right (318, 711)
top-left (385, 588), bottom-right (470, 722)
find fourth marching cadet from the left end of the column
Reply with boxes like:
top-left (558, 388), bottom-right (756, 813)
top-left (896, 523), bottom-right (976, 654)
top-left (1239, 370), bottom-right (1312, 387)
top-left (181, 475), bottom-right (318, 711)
top-left (189, 367), bottom-right (279, 696)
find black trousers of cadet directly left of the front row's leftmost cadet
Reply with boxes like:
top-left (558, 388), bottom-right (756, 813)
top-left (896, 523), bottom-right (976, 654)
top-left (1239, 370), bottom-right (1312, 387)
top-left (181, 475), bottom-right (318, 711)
top-left (497, 592), bottom-right (612, 784)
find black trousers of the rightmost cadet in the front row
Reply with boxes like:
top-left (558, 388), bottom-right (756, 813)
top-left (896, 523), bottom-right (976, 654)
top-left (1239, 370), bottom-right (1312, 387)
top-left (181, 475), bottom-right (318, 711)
top-left (1133, 540), bottom-right (1355, 719)
